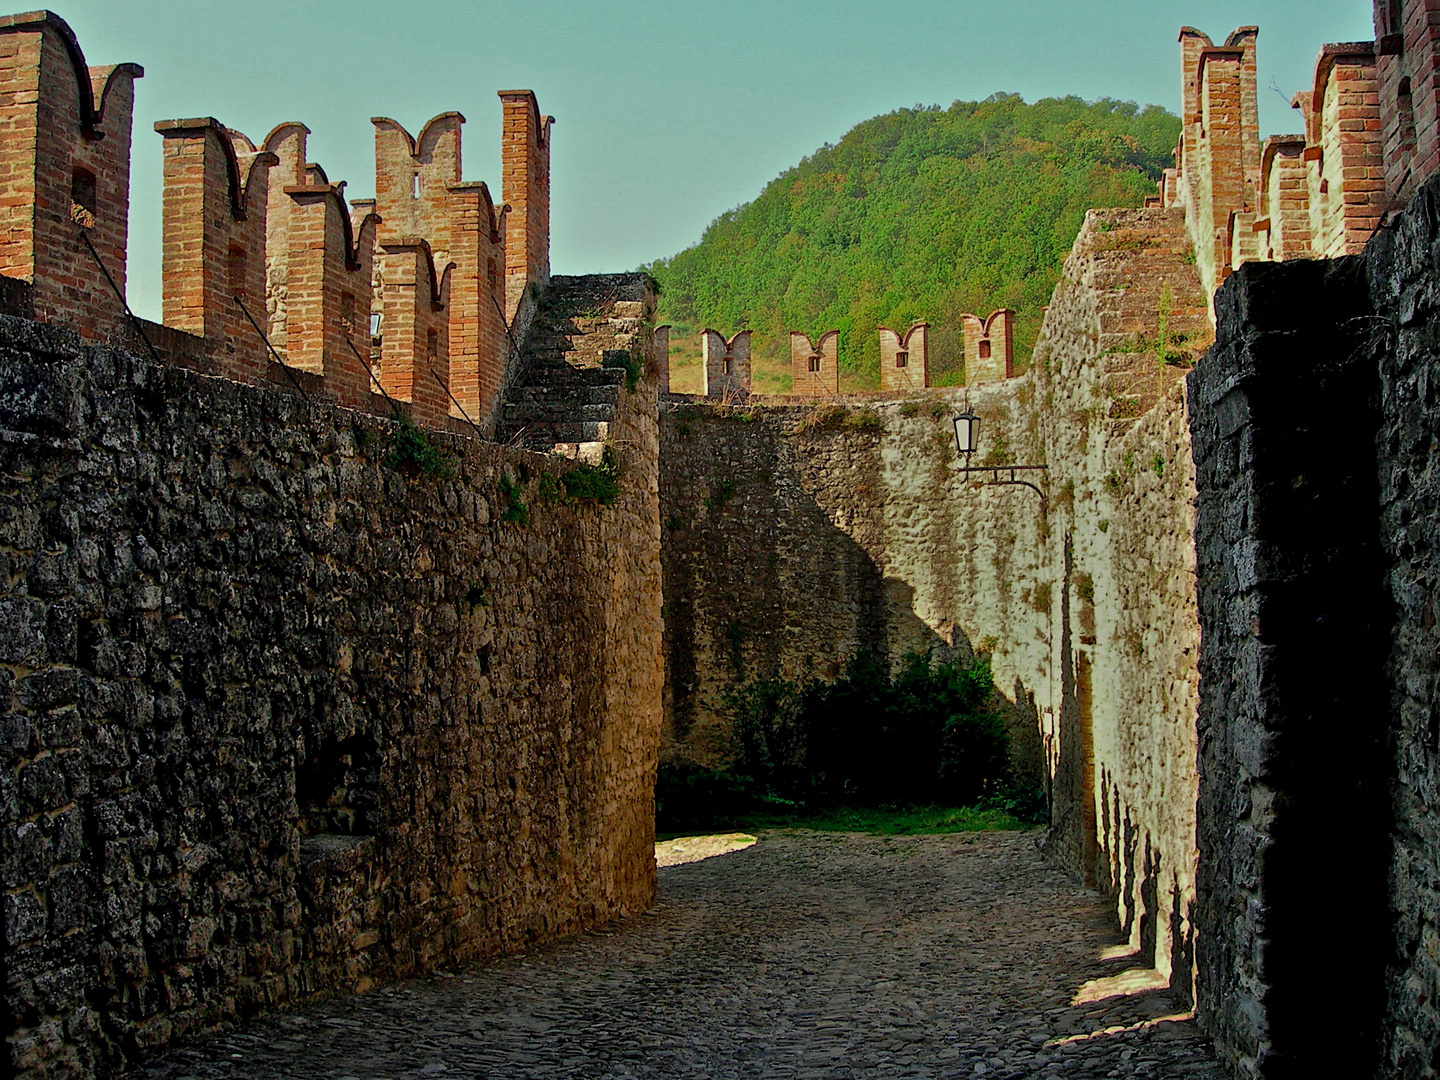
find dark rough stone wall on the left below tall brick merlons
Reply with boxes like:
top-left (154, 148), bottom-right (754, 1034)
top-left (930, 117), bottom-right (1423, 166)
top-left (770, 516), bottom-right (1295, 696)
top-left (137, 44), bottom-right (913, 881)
top-left (0, 318), bottom-right (662, 1077)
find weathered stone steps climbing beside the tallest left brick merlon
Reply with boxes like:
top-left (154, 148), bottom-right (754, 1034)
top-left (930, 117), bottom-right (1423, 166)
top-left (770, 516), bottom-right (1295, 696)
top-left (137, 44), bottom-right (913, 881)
top-left (495, 274), bottom-right (647, 456)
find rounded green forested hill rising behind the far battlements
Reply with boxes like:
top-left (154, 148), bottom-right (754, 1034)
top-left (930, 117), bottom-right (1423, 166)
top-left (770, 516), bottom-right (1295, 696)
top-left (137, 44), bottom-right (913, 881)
top-left (647, 95), bottom-right (1179, 392)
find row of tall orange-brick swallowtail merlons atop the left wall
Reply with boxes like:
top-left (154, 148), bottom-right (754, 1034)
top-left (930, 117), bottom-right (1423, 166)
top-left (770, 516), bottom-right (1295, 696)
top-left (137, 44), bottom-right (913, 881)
top-left (0, 12), bottom-right (553, 431)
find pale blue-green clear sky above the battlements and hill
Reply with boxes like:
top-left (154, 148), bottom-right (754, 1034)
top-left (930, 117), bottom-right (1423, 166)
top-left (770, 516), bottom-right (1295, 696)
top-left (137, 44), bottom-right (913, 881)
top-left (56, 0), bottom-right (1374, 321)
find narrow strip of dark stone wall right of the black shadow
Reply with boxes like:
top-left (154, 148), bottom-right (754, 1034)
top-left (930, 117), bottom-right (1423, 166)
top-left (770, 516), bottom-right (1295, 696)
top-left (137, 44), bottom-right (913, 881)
top-left (1367, 169), bottom-right (1440, 1080)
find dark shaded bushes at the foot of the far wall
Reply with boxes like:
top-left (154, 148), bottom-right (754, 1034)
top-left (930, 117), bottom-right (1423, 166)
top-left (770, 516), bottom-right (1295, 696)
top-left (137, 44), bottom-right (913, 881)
top-left (657, 652), bottom-right (1043, 832)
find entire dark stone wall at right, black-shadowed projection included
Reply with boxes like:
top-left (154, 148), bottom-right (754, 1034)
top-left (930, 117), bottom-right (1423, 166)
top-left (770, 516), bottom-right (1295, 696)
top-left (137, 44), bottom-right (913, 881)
top-left (1191, 169), bottom-right (1440, 1080)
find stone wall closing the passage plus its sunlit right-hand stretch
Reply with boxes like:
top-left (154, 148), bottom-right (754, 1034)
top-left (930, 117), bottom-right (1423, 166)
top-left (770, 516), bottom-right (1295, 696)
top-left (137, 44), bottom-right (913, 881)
top-left (661, 210), bottom-right (1210, 989)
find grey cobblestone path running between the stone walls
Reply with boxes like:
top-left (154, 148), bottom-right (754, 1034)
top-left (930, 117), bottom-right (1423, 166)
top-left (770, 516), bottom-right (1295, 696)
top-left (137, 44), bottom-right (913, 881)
top-left (138, 832), bottom-right (1227, 1080)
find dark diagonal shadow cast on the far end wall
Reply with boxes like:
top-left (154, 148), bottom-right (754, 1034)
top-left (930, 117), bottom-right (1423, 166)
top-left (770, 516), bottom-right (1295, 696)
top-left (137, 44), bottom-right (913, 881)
top-left (661, 416), bottom-right (1043, 786)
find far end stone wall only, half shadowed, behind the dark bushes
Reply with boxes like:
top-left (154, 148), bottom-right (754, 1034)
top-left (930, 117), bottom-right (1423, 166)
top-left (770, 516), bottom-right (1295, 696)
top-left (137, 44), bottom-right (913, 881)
top-left (661, 384), bottom-right (1047, 780)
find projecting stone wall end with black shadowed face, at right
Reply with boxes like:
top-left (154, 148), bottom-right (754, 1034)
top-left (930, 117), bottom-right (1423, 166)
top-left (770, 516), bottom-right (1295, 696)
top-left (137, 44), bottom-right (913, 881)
top-left (1189, 258), bottom-right (1388, 1077)
